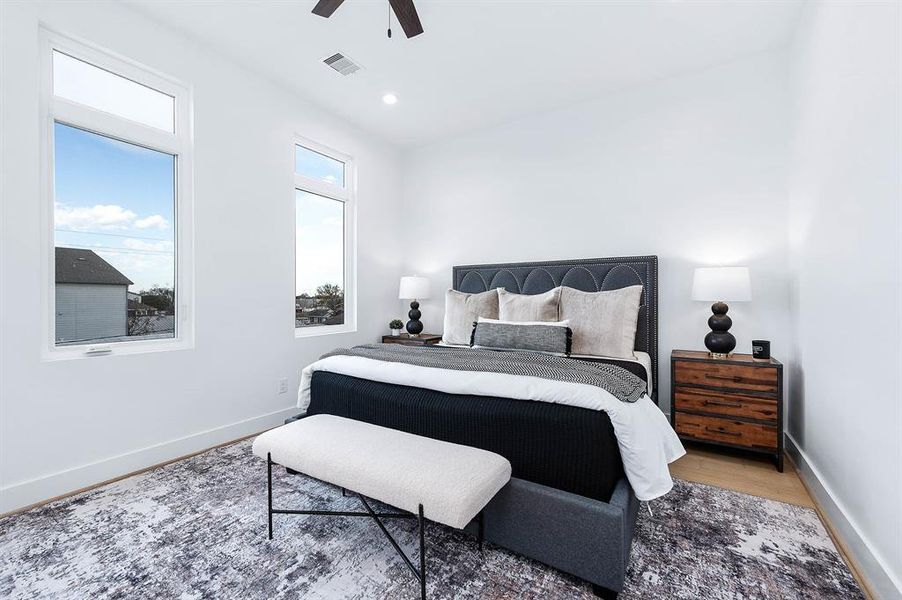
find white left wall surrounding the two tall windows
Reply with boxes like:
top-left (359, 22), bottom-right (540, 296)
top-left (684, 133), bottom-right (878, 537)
top-left (0, 2), bottom-right (401, 512)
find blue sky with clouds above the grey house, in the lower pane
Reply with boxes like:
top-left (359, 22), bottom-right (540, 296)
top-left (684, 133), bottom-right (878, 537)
top-left (54, 123), bottom-right (175, 292)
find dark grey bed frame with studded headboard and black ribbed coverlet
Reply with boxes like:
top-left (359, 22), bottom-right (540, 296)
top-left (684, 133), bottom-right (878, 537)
top-left (298, 256), bottom-right (672, 597)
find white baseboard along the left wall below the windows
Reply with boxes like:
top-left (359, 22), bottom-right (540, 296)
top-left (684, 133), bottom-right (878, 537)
top-left (0, 406), bottom-right (298, 514)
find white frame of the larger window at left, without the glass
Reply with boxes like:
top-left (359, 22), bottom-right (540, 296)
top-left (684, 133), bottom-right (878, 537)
top-left (39, 28), bottom-right (194, 360)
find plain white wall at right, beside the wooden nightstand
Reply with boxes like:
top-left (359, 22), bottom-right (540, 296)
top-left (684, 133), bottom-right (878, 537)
top-left (789, 2), bottom-right (902, 598)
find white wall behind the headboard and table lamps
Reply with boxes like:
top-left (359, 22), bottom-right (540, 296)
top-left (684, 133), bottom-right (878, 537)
top-left (404, 54), bottom-right (789, 411)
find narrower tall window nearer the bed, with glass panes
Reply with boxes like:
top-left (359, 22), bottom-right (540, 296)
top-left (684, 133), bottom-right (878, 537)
top-left (294, 141), bottom-right (355, 336)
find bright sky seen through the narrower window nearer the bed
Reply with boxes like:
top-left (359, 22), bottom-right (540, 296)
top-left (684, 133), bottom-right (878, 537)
top-left (295, 146), bottom-right (345, 295)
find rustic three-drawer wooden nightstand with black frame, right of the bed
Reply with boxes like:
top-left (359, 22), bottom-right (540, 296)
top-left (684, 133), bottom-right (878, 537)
top-left (670, 350), bottom-right (783, 473)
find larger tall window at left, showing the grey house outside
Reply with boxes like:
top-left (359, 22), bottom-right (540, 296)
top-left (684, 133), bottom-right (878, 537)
top-left (43, 33), bottom-right (191, 354)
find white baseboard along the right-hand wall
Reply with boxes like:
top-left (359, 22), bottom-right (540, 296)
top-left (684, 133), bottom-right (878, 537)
top-left (786, 433), bottom-right (902, 600)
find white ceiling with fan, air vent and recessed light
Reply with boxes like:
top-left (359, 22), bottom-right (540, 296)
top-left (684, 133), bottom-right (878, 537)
top-left (130, 0), bottom-right (803, 146)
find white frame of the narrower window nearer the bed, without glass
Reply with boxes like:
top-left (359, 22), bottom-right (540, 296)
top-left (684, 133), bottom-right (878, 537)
top-left (291, 134), bottom-right (357, 338)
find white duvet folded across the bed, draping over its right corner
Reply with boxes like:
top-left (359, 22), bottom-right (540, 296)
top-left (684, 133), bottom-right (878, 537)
top-left (298, 356), bottom-right (686, 501)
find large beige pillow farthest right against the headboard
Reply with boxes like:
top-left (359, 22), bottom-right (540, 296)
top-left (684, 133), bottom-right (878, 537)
top-left (561, 285), bottom-right (642, 358)
